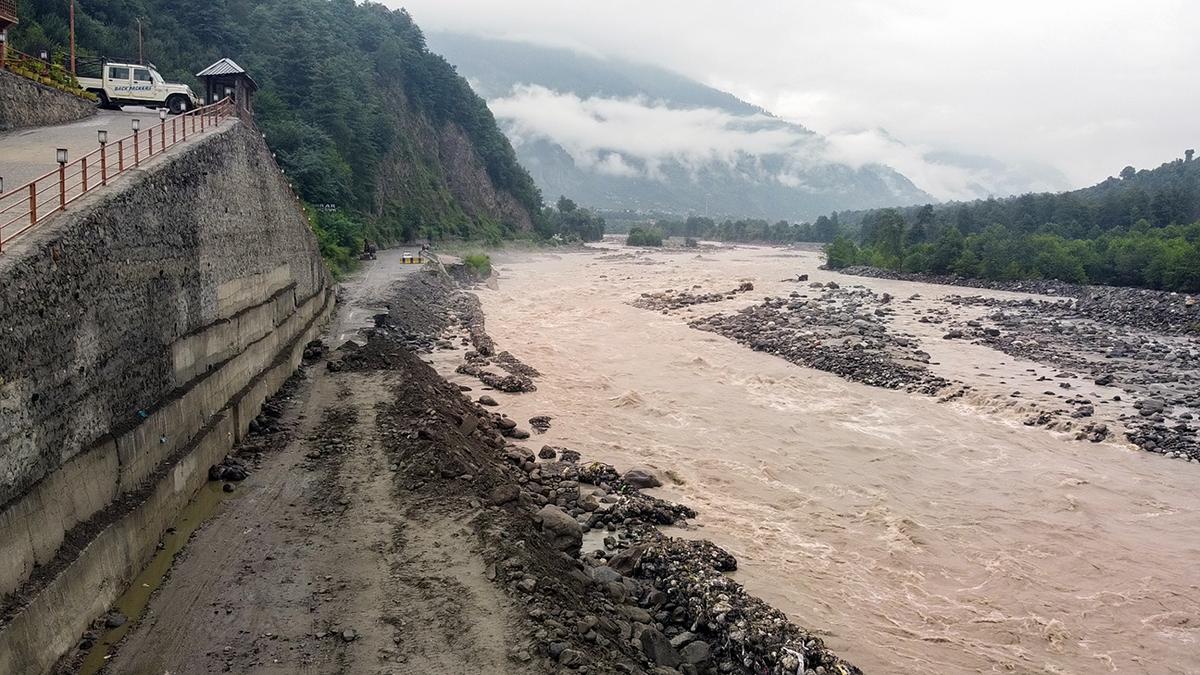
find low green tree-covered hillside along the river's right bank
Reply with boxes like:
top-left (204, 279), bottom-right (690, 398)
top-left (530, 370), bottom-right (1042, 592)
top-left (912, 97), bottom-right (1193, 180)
top-left (827, 150), bottom-right (1200, 292)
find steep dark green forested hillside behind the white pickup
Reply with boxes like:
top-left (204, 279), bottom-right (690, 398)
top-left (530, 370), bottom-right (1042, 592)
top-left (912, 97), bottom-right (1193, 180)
top-left (12, 0), bottom-right (541, 264)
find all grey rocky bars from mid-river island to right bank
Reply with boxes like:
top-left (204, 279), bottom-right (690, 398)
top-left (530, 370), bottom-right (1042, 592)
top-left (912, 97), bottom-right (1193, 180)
top-left (630, 263), bottom-right (1200, 462)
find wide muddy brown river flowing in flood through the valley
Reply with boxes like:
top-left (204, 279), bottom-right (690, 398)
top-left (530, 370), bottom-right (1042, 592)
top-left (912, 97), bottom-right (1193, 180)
top-left (436, 247), bottom-right (1200, 673)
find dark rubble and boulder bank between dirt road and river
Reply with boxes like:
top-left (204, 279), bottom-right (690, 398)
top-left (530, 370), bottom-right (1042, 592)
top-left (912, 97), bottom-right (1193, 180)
top-left (348, 267), bottom-right (859, 675)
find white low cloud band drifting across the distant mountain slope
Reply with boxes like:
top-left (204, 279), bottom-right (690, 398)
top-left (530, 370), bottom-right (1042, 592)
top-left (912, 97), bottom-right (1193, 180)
top-left (490, 84), bottom-right (1064, 199)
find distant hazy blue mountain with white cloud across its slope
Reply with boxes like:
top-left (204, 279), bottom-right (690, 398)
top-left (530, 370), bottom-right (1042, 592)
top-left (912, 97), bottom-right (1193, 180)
top-left (428, 32), bottom-right (1067, 220)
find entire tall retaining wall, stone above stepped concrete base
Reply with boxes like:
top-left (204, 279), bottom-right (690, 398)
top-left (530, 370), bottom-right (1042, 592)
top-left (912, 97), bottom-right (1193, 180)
top-left (0, 118), bottom-right (334, 673)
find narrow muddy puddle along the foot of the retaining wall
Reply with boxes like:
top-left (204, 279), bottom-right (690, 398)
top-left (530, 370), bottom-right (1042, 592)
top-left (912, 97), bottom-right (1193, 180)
top-left (79, 480), bottom-right (235, 675)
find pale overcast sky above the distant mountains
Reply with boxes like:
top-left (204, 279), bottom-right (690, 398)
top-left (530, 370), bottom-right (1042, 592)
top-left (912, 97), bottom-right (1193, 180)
top-left (385, 0), bottom-right (1200, 194)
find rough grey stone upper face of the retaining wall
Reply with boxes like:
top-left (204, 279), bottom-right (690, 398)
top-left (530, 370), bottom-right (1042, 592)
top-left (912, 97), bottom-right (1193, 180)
top-left (0, 124), bottom-right (326, 504)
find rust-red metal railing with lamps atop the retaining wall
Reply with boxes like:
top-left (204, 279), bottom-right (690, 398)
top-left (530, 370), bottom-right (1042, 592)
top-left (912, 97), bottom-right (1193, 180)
top-left (0, 98), bottom-right (238, 253)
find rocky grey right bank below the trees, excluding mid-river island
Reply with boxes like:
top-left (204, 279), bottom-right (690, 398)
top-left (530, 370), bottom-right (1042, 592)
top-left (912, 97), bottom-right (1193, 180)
top-left (840, 267), bottom-right (1200, 462)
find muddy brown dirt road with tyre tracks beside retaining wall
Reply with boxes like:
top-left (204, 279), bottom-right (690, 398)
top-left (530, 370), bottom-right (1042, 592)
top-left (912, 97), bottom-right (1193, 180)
top-left (106, 265), bottom-right (532, 674)
